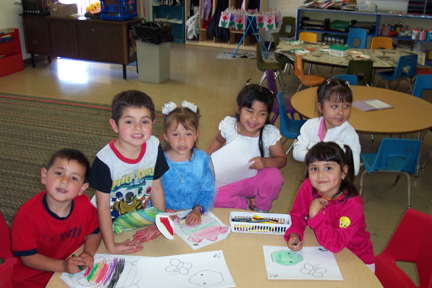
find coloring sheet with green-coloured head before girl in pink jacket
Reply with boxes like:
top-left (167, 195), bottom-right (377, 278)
top-left (263, 246), bottom-right (343, 280)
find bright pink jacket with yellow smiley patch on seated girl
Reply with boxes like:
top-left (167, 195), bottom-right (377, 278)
top-left (284, 178), bottom-right (375, 264)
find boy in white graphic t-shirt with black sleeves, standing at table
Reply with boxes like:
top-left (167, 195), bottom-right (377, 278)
top-left (89, 90), bottom-right (169, 254)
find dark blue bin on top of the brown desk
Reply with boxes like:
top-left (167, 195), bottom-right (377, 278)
top-left (100, 0), bottom-right (138, 21)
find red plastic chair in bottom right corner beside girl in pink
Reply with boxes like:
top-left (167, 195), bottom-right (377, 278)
top-left (375, 209), bottom-right (432, 288)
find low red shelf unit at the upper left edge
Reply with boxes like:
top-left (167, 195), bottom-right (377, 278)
top-left (0, 28), bottom-right (24, 77)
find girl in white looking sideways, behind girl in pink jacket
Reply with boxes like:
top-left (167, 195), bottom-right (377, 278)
top-left (293, 79), bottom-right (361, 175)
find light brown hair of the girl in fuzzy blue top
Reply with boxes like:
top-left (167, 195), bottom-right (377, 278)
top-left (162, 107), bottom-right (201, 151)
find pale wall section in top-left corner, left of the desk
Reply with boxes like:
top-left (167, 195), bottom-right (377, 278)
top-left (0, 0), bottom-right (30, 59)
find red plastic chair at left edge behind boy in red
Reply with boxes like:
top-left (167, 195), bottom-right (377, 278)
top-left (0, 211), bottom-right (18, 288)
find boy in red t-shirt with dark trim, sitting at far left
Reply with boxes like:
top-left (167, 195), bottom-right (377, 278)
top-left (12, 149), bottom-right (101, 288)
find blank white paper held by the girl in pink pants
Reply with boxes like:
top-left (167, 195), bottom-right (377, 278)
top-left (211, 137), bottom-right (258, 187)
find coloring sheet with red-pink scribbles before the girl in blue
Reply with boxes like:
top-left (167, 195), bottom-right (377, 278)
top-left (174, 209), bottom-right (231, 250)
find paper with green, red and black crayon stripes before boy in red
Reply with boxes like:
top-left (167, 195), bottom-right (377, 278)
top-left (60, 254), bottom-right (151, 288)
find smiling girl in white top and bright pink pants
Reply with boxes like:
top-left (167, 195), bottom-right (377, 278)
top-left (206, 84), bottom-right (287, 212)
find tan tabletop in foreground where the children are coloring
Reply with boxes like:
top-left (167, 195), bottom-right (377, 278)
top-left (46, 208), bottom-right (382, 288)
